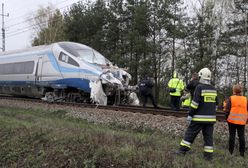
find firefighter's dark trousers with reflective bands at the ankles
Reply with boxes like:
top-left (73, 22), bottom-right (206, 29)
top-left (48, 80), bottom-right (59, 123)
top-left (180, 122), bottom-right (214, 157)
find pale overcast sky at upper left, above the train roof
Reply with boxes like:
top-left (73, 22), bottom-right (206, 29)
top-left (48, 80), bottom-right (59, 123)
top-left (0, 0), bottom-right (197, 51)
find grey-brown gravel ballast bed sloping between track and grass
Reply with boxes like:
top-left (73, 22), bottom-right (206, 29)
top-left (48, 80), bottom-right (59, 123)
top-left (0, 99), bottom-right (248, 141)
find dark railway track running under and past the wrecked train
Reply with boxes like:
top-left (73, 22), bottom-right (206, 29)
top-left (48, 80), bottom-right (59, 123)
top-left (0, 95), bottom-right (225, 121)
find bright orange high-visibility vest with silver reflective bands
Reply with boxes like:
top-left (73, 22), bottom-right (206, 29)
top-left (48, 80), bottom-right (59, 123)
top-left (227, 95), bottom-right (248, 125)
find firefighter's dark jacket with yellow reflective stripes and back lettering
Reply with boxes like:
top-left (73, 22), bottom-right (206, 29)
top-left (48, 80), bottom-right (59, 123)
top-left (189, 83), bottom-right (217, 123)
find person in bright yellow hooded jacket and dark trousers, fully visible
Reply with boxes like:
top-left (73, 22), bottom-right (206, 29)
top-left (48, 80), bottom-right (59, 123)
top-left (168, 72), bottom-right (184, 111)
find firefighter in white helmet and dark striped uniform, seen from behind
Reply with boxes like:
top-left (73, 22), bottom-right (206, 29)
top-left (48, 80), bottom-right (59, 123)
top-left (177, 68), bottom-right (217, 160)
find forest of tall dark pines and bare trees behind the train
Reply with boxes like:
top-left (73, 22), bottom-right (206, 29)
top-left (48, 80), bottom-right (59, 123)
top-left (31, 0), bottom-right (248, 103)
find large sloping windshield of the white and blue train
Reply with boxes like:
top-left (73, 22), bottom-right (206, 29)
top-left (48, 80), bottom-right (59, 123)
top-left (59, 42), bottom-right (111, 65)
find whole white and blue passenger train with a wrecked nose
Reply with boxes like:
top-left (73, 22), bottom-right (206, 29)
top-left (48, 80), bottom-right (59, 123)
top-left (0, 41), bottom-right (139, 105)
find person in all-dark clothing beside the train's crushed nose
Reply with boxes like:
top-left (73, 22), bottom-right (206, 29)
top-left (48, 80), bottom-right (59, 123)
top-left (139, 76), bottom-right (158, 108)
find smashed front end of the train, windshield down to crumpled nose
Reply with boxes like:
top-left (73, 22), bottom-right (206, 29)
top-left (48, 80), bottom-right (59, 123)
top-left (55, 42), bottom-right (139, 105)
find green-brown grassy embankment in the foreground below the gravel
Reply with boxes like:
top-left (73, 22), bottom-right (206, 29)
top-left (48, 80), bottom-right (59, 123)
top-left (0, 108), bottom-right (248, 168)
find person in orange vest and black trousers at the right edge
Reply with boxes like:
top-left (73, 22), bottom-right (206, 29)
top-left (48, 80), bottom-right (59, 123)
top-left (224, 85), bottom-right (248, 157)
